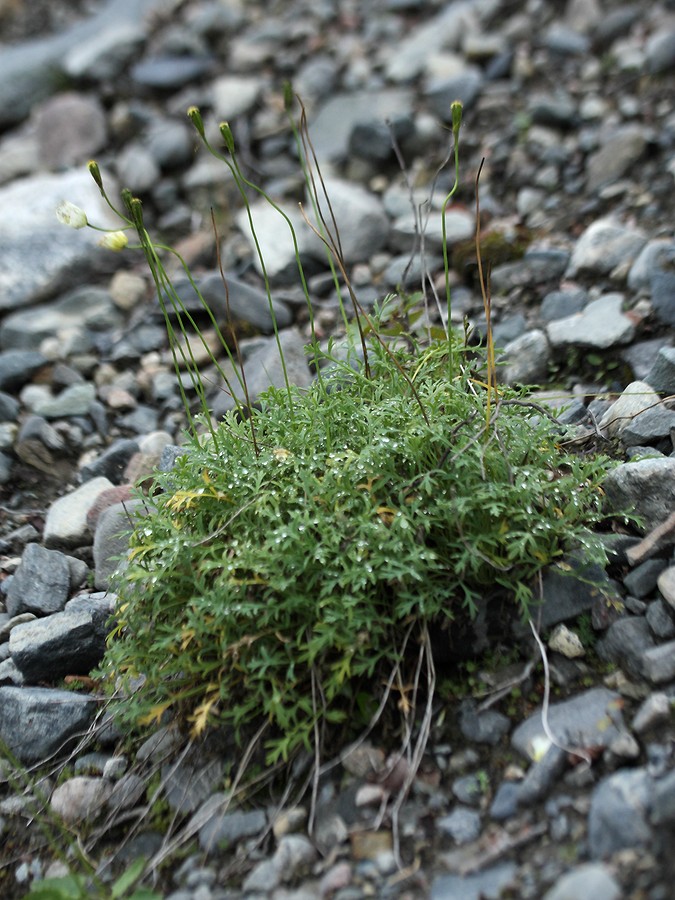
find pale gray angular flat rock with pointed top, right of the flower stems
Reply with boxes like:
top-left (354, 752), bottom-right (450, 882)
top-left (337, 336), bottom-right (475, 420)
top-left (546, 294), bottom-right (635, 350)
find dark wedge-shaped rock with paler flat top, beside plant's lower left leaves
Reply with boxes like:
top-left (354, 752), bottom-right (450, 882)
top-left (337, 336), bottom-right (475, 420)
top-left (9, 610), bottom-right (105, 684)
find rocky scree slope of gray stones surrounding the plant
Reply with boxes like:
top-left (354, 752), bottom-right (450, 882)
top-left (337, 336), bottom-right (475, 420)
top-left (0, 0), bottom-right (675, 900)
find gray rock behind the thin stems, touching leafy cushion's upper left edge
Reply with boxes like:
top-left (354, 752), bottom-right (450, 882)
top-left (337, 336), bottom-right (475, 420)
top-left (210, 329), bottom-right (312, 418)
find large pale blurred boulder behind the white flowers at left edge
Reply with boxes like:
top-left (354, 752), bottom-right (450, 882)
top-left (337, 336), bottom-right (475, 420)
top-left (0, 169), bottom-right (120, 312)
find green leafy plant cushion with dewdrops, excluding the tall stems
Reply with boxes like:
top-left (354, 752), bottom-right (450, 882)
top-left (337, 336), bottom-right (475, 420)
top-left (103, 342), bottom-right (607, 762)
